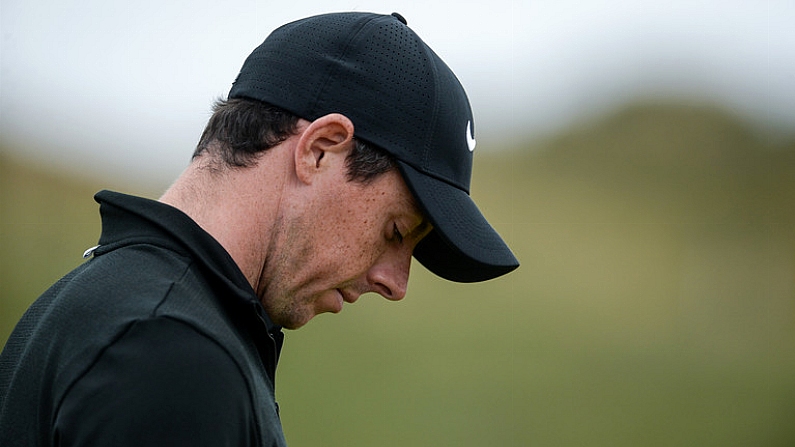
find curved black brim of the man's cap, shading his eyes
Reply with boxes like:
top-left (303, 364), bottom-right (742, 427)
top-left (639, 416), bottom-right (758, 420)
top-left (398, 160), bottom-right (519, 282)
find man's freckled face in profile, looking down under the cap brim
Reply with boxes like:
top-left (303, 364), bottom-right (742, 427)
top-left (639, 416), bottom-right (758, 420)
top-left (258, 166), bottom-right (431, 329)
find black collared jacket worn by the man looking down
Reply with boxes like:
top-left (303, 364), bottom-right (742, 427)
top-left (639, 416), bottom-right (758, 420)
top-left (0, 191), bottom-right (285, 447)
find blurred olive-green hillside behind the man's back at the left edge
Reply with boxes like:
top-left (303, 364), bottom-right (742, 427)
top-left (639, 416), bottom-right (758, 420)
top-left (0, 154), bottom-right (104, 344)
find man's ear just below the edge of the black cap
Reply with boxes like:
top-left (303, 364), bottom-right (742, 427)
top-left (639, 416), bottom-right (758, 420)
top-left (295, 113), bottom-right (353, 183)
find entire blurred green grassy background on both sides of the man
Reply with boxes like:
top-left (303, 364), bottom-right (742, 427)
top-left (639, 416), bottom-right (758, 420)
top-left (0, 103), bottom-right (795, 447)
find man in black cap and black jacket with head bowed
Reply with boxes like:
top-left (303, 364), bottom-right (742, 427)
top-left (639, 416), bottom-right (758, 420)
top-left (0, 13), bottom-right (518, 446)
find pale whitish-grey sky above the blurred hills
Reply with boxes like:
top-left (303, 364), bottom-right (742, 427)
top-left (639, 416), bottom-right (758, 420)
top-left (0, 0), bottom-right (795, 183)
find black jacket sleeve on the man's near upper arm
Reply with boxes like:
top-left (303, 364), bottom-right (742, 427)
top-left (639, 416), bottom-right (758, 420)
top-left (54, 317), bottom-right (257, 447)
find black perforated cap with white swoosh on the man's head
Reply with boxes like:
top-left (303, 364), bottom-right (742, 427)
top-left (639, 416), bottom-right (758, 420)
top-left (229, 12), bottom-right (519, 282)
